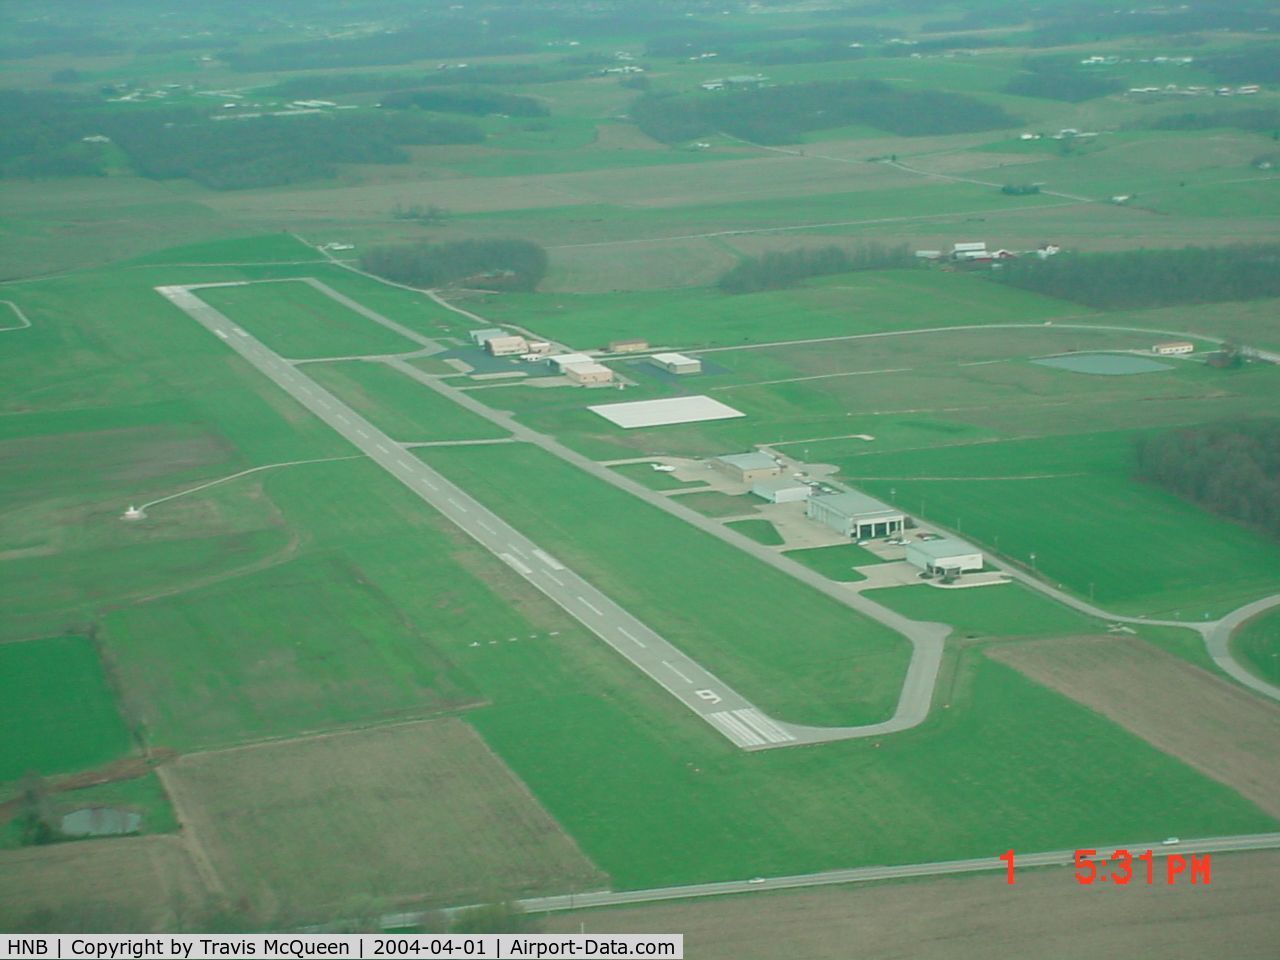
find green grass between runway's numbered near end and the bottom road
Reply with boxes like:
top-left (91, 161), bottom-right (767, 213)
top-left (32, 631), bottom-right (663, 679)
top-left (470, 653), bottom-right (1276, 888)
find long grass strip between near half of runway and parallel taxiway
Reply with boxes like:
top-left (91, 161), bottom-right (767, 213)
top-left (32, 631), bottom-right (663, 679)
top-left (419, 444), bottom-right (910, 724)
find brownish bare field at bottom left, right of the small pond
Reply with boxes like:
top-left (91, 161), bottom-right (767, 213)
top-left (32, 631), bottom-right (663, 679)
top-left (165, 719), bottom-right (607, 920)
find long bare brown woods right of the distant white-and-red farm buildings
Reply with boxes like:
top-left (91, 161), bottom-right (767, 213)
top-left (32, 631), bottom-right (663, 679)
top-left (989, 243), bottom-right (1280, 310)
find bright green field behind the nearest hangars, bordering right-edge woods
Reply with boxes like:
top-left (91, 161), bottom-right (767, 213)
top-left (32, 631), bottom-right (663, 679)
top-left (840, 431), bottom-right (1280, 620)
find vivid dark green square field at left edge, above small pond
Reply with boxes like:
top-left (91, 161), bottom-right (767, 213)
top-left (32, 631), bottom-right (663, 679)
top-left (0, 636), bottom-right (131, 782)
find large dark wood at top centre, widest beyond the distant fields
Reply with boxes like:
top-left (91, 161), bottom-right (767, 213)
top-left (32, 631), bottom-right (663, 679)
top-left (631, 79), bottom-right (1016, 143)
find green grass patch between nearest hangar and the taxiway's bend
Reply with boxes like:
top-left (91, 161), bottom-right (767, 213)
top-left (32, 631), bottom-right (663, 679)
top-left (864, 584), bottom-right (1103, 637)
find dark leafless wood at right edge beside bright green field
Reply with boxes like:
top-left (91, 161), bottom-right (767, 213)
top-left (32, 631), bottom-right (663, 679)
top-left (1137, 420), bottom-right (1280, 538)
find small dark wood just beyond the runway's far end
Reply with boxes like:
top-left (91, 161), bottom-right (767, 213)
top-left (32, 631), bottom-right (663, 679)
top-left (360, 239), bottom-right (547, 291)
